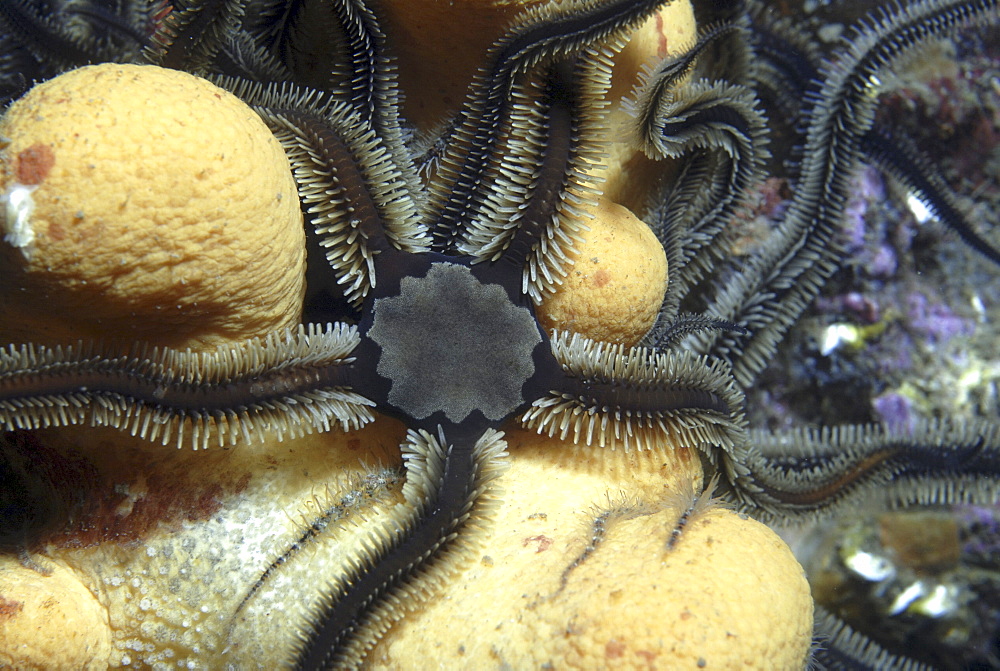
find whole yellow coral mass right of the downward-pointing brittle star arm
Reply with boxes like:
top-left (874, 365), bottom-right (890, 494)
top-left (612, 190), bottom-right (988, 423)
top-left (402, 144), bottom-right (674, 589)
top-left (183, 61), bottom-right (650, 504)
top-left (369, 431), bottom-right (812, 669)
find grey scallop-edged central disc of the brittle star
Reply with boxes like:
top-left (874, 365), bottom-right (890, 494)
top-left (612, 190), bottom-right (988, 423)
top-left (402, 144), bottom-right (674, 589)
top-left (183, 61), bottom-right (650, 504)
top-left (368, 262), bottom-right (542, 423)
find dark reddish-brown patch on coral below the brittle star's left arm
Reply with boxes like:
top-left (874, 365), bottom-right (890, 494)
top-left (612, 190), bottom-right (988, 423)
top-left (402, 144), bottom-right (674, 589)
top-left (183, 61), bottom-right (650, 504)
top-left (0, 431), bottom-right (251, 551)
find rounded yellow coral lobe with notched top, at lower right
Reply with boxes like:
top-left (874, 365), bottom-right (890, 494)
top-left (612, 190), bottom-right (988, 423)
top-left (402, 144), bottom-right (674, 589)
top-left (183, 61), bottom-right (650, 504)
top-left (552, 508), bottom-right (813, 670)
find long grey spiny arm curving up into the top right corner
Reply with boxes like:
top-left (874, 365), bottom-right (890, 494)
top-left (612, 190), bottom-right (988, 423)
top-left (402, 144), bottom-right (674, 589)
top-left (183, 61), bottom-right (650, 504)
top-left (698, 0), bottom-right (997, 385)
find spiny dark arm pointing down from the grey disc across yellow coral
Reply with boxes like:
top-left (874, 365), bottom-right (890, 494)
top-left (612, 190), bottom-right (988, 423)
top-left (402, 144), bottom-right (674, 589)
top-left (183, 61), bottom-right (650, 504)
top-left (290, 427), bottom-right (506, 669)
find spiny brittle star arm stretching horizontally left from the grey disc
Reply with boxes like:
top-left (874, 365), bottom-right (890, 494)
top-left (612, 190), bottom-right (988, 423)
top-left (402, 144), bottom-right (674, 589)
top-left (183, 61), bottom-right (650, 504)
top-left (0, 324), bottom-right (374, 449)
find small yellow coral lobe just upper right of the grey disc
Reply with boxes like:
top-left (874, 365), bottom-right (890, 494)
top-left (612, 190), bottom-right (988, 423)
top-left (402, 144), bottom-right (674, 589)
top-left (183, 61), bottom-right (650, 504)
top-left (538, 199), bottom-right (667, 346)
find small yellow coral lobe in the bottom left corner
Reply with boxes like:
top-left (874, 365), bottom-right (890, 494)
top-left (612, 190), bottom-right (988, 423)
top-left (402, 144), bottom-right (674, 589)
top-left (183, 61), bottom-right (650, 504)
top-left (0, 560), bottom-right (111, 669)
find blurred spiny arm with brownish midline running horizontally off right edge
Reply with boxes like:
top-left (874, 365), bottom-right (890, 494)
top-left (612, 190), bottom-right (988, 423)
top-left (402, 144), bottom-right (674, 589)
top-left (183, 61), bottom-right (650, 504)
top-left (724, 421), bottom-right (1000, 522)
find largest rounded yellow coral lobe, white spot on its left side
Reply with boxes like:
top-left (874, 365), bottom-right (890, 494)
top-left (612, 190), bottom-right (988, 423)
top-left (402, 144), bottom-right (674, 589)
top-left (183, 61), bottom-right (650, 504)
top-left (0, 64), bottom-right (305, 348)
